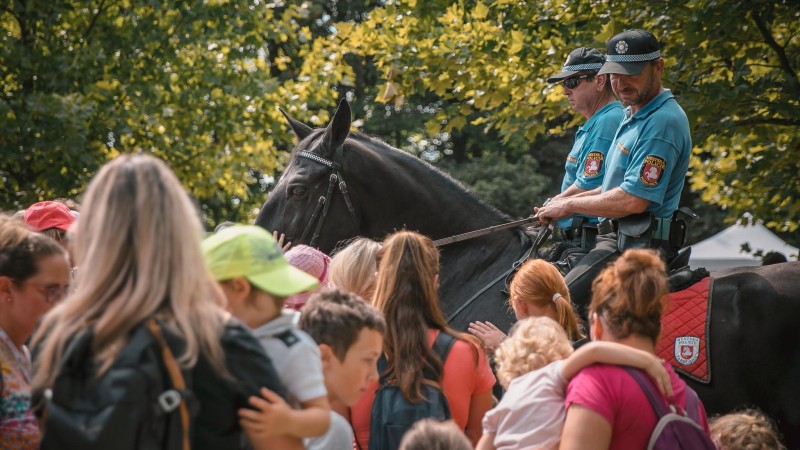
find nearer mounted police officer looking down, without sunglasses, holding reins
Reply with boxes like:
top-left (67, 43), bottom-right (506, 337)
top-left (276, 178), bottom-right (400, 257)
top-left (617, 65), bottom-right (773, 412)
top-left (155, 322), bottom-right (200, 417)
top-left (535, 30), bottom-right (692, 314)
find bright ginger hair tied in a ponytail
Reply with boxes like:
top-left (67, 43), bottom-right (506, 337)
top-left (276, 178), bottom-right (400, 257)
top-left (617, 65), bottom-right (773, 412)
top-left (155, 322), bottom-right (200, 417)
top-left (509, 259), bottom-right (584, 341)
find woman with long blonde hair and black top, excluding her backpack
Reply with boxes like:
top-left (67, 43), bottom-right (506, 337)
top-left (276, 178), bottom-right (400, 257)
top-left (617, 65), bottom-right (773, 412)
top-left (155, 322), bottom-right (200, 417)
top-left (33, 155), bottom-right (300, 449)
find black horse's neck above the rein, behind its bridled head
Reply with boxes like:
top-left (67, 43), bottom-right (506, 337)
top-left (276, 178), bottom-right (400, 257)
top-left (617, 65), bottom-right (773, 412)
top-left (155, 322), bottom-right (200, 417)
top-left (348, 142), bottom-right (508, 239)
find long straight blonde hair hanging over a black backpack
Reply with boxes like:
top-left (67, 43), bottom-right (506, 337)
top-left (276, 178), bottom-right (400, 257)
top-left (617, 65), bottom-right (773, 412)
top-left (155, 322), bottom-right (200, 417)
top-left (33, 155), bottom-right (226, 389)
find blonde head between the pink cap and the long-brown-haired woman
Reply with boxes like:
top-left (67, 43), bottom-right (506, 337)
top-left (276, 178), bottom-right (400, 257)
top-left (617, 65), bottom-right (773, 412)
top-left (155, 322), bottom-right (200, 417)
top-left (329, 237), bottom-right (381, 300)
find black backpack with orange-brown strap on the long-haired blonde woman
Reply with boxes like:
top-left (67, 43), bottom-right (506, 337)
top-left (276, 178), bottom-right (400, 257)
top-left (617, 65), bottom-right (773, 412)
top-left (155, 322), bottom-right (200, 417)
top-left (41, 320), bottom-right (196, 450)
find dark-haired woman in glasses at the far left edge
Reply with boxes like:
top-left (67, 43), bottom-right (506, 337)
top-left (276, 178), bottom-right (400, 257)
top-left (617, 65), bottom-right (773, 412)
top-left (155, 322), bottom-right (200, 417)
top-left (0, 214), bottom-right (70, 450)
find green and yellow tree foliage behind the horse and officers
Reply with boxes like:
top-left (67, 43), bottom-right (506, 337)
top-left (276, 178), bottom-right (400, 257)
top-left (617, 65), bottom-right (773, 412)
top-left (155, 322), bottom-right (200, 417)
top-left (0, 0), bottom-right (800, 244)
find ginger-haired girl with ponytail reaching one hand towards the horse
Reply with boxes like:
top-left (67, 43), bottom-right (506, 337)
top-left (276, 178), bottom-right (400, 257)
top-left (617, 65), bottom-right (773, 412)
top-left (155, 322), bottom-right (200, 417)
top-left (469, 259), bottom-right (585, 350)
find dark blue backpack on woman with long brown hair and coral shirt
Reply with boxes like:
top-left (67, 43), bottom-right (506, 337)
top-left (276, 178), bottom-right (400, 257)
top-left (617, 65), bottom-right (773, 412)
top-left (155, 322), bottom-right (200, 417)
top-left (369, 331), bottom-right (456, 450)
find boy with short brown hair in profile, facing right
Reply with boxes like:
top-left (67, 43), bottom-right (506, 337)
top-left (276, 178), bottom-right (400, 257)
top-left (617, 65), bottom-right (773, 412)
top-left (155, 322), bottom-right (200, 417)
top-left (299, 289), bottom-right (386, 450)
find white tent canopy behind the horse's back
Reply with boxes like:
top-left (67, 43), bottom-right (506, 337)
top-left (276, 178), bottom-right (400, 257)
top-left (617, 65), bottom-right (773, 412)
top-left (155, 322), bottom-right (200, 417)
top-left (689, 223), bottom-right (800, 271)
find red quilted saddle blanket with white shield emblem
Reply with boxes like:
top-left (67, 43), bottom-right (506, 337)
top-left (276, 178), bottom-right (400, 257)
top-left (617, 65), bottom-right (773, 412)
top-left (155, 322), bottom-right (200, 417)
top-left (656, 277), bottom-right (711, 383)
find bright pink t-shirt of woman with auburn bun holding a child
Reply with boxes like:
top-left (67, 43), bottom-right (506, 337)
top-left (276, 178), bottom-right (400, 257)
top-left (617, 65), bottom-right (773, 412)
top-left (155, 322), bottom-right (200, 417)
top-left (565, 363), bottom-right (709, 450)
